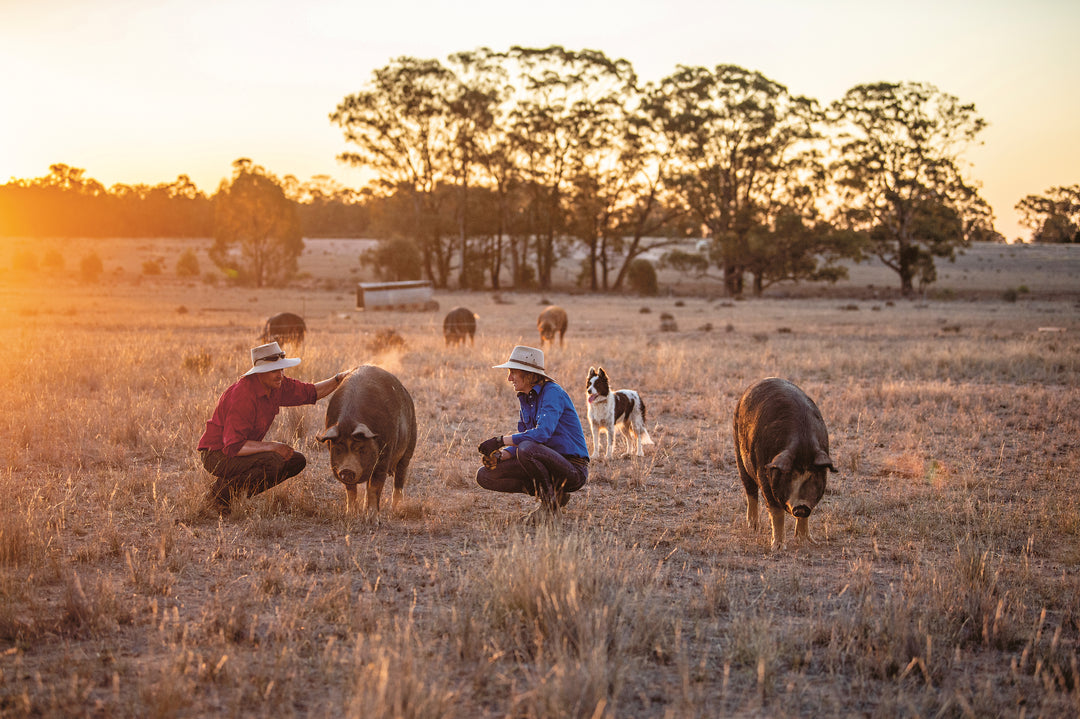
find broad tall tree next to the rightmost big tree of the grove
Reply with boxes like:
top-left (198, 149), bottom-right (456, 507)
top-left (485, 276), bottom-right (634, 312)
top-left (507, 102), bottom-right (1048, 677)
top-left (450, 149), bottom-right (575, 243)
top-left (647, 65), bottom-right (823, 296)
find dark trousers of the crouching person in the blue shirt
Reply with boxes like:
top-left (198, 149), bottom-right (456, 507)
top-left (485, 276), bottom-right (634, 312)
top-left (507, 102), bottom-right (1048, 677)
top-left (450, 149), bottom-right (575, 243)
top-left (476, 439), bottom-right (589, 500)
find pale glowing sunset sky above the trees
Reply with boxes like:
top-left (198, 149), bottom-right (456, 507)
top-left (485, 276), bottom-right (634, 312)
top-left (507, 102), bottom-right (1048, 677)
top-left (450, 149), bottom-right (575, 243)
top-left (0, 0), bottom-right (1080, 241)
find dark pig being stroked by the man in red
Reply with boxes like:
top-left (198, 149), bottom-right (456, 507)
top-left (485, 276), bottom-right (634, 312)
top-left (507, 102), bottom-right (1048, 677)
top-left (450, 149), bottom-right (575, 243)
top-left (318, 365), bottom-right (416, 513)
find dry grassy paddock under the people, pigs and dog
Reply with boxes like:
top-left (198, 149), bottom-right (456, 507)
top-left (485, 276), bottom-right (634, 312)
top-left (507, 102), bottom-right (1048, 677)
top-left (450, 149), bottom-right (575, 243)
top-left (0, 241), bottom-right (1080, 719)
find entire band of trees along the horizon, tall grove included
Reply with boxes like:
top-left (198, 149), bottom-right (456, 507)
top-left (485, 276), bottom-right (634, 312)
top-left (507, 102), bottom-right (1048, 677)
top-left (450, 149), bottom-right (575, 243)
top-left (6, 46), bottom-right (1080, 296)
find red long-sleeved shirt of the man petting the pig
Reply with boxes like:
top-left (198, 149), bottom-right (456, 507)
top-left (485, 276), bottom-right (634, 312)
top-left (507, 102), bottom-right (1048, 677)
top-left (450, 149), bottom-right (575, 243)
top-left (199, 375), bottom-right (318, 457)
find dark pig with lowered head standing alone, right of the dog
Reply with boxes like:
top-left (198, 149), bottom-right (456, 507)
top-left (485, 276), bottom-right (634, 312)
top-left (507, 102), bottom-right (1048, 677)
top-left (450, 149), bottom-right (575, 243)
top-left (734, 377), bottom-right (836, 551)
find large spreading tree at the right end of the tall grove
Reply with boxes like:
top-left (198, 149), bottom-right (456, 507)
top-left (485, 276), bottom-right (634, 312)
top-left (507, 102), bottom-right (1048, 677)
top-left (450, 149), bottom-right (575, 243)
top-left (831, 82), bottom-right (993, 295)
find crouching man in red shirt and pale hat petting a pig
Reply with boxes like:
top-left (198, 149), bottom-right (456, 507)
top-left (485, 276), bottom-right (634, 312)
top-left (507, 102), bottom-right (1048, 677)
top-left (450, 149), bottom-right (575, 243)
top-left (199, 342), bottom-right (352, 514)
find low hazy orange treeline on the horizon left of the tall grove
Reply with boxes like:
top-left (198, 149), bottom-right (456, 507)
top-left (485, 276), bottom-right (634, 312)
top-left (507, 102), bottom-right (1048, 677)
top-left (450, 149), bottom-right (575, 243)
top-left (0, 164), bottom-right (369, 238)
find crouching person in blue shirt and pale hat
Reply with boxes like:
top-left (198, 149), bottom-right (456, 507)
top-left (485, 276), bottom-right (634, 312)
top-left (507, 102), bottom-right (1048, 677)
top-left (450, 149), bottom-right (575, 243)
top-left (476, 345), bottom-right (589, 520)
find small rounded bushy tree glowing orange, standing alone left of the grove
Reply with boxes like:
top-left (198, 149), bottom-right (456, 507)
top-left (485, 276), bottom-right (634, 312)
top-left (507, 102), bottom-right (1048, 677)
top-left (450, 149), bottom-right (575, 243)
top-left (210, 158), bottom-right (303, 287)
